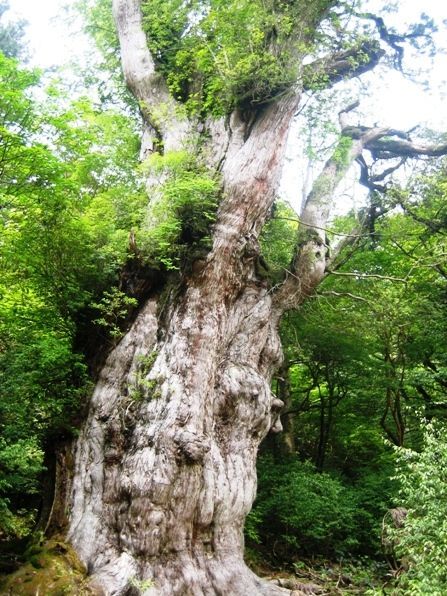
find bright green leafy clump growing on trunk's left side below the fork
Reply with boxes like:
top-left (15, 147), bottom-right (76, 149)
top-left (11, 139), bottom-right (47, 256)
top-left (138, 151), bottom-right (219, 270)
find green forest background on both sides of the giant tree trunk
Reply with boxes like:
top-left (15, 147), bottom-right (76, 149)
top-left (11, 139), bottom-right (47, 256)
top-left (0, 2), bottom-right (447, 594)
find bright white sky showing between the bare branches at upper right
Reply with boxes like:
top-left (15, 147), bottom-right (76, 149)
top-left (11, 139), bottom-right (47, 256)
top-left (279, 0), bottom-right (447, 214)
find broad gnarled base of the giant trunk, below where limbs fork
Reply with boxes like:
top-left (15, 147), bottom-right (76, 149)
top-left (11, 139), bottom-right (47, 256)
top-left (69, 236), bottom-right (290, 595)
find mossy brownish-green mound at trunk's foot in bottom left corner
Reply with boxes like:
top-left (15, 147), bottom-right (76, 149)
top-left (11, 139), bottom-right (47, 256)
top-left (0, 540), bottom-right (98, 596)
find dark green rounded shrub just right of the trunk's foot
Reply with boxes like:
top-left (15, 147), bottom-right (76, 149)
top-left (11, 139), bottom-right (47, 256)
top-left (248, 456), bottom-right (358, 558)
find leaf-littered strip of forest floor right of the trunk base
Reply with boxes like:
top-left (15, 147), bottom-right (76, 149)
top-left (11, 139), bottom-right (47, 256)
top-left (249, 558), bottom-right (394, 596)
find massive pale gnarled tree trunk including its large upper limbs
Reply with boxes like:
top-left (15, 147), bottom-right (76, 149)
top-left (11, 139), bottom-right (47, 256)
top-left (64, 0), bottom-right (447, 596)
